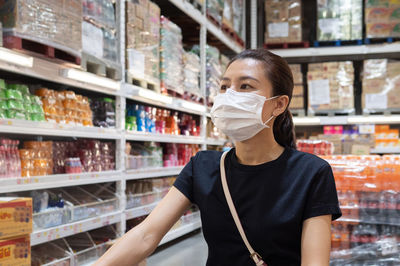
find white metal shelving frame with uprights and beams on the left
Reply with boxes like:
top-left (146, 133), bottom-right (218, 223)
top-left (0, 0), bottom-right (243, 254)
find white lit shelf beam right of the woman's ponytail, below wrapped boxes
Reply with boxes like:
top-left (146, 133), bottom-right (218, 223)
top-left (293, 115), bottom-right (400, 126)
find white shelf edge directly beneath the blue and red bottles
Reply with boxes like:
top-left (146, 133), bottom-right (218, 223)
top-left (125, 131), bottom-right (204, 144)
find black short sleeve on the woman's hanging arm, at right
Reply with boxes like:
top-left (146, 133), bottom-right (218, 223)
top-left (303, 163), bottom-right (342, 220)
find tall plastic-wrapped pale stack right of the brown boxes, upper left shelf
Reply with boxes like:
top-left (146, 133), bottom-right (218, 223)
top-left (160, 16), bottom-right (184, 94)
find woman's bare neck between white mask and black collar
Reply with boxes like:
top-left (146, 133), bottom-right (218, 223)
top-left (235, 130), bottom-right (285, 165)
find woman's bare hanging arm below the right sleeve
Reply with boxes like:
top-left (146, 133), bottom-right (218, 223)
top-left (301, 215), bottom-right (332, 266)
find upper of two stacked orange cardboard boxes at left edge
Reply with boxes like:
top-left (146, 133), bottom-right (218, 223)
top-left (0, 197), bottom-right (32, 240)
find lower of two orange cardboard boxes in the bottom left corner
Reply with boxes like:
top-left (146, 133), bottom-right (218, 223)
top-left (0, 235), bottom-right (29, 266)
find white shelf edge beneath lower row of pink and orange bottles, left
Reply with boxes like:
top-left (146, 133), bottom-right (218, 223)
top-left (0, 171), bottom-right (122, 193)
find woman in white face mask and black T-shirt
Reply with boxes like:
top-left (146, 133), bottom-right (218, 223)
top-left (96, 49), bottom-right (341, 266)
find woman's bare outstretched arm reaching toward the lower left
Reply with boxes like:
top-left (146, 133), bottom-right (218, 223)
top-left (94, 187), bottom-right (191, 266)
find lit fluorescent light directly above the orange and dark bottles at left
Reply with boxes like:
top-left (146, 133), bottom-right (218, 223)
top-left (61, 69), bottom-right (120, 90)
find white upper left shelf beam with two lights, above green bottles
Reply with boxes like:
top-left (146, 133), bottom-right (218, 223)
top-left (0, 47), bottom-right (120, 95)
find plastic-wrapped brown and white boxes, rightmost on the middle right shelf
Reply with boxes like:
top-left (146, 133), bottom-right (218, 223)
top-left (362, 59), bottom-right (400, 113)
